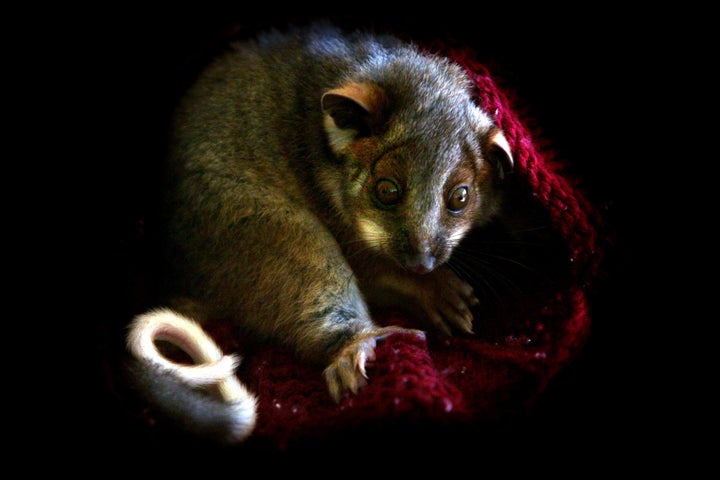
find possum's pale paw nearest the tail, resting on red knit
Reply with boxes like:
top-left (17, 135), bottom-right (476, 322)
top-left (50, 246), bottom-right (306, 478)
top-left (323, 326), bottom-right (425, 402)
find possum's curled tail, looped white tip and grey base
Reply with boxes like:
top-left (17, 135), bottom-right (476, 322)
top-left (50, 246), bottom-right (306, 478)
top-left (127, 308), bottom-right (257, 444)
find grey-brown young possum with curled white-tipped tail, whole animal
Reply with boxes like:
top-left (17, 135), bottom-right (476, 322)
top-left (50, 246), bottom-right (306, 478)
top-left (128, 24), bottom-right (513, 442)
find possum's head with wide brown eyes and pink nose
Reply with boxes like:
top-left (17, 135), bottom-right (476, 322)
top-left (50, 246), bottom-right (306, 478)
top-left (319, 57), bottom-right (513, 273)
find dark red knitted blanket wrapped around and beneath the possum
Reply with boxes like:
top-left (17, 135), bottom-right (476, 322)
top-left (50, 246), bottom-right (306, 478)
top-left (100, 35), bottom-right (602, 450)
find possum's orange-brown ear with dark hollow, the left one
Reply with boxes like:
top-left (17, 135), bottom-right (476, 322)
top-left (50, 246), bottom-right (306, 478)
top-left (320, 82), bottom-right (386, 151)
